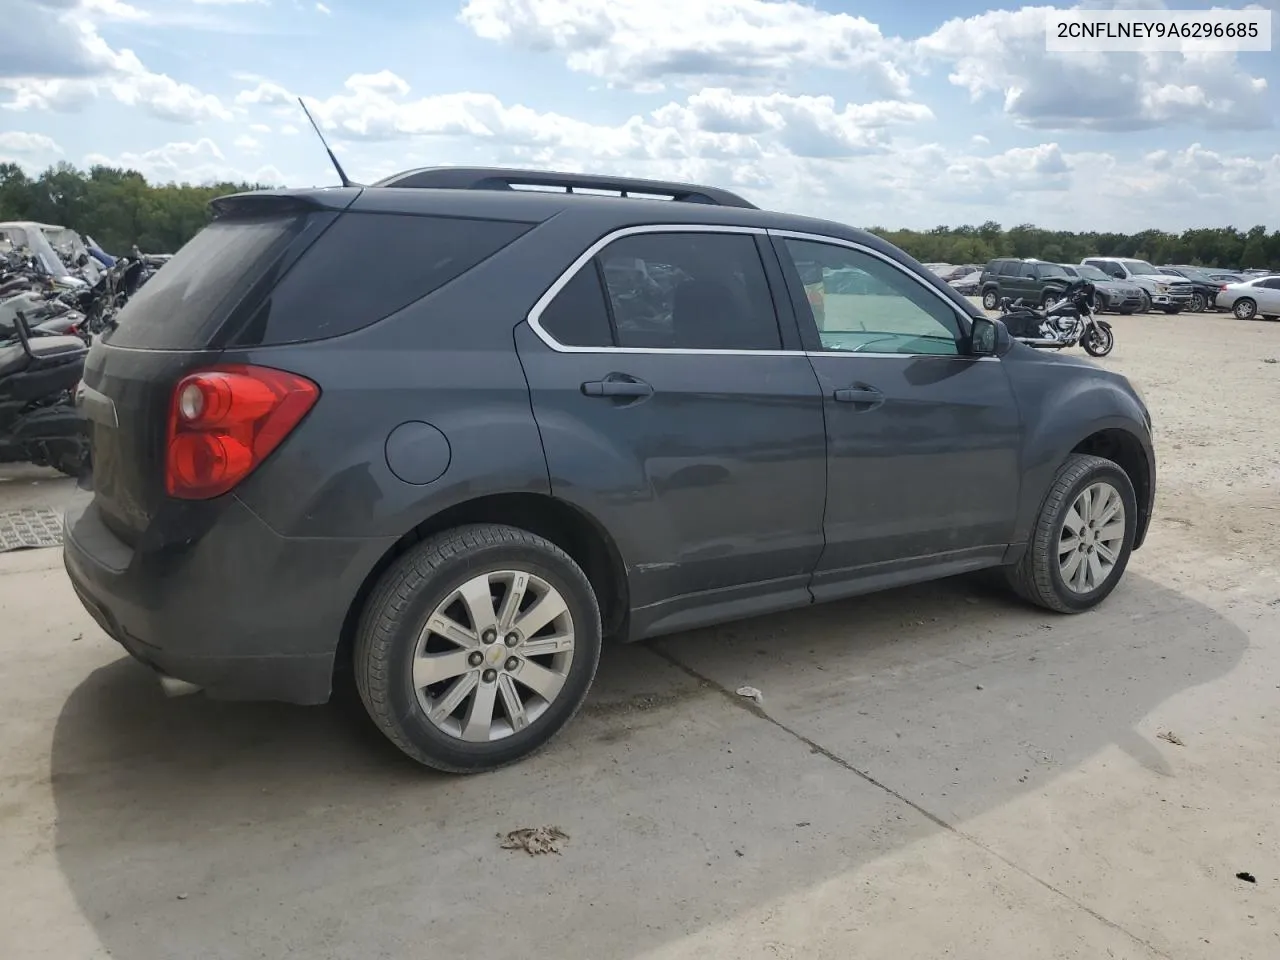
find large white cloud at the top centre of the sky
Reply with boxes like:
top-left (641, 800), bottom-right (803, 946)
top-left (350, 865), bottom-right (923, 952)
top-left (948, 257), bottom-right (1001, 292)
top-left (458, 0), bottom-right (909, 97)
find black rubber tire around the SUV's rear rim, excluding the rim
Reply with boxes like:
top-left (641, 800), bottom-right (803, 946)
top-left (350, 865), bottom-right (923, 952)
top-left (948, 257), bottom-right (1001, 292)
top-left (353, 524), bottom-right (600, 773)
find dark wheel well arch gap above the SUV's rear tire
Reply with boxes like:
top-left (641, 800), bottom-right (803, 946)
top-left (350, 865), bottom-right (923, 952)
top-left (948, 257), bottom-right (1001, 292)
top-left (334, 493), bottom-right (630, 686)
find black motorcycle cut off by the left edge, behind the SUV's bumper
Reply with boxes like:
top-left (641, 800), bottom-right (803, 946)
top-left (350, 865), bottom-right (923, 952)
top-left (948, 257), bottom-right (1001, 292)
top-left (0, 310), bottom-right (90, 476)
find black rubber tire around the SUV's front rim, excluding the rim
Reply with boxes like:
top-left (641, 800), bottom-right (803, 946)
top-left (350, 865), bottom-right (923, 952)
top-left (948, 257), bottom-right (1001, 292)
top-left (1005, 453), bottom-right (1138, 613)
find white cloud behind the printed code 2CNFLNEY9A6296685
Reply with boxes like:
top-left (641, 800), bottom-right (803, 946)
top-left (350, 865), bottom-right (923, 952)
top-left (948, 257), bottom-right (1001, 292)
top-left (914, 6), bottom-right (1271, 132)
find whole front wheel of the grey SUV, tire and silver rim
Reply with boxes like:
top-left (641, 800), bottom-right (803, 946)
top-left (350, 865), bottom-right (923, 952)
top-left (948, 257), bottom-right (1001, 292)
top-left (1005, 453), bottom-right (1138, 613)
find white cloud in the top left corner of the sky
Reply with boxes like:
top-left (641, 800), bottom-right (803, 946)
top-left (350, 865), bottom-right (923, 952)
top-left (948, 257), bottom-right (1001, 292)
top-left (0, 0), bottom-right (230, 123)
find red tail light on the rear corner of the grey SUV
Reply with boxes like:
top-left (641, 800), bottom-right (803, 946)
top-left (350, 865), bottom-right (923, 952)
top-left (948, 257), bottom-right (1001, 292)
top-left (165, 365), bottom-right (320, 500)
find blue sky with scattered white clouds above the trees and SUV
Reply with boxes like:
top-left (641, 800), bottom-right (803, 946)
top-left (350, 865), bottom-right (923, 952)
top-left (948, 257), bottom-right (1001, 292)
top-left (0, 0), bottom-right (1280, 232)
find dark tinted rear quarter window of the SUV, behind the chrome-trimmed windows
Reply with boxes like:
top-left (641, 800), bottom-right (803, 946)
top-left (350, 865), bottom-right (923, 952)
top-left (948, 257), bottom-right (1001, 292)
top-left (232, 212), bottom-right (532, 346)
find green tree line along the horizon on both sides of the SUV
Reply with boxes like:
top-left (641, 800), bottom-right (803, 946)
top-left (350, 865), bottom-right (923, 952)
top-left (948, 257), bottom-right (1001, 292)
top-left (0, 164), bottom-right (1280, 270)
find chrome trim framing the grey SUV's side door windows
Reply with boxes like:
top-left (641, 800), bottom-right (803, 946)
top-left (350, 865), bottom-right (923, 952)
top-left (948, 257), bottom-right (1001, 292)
top-left (525, 223), bottom-right (1000, 361)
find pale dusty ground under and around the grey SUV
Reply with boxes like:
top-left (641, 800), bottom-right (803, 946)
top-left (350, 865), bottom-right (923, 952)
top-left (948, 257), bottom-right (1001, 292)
top-left (0, 315), bottom-right (1280, 960)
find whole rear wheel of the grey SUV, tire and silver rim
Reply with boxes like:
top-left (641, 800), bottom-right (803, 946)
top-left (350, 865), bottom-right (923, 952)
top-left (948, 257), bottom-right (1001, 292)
top-left (353, 524), bottom-right (600, 773)
